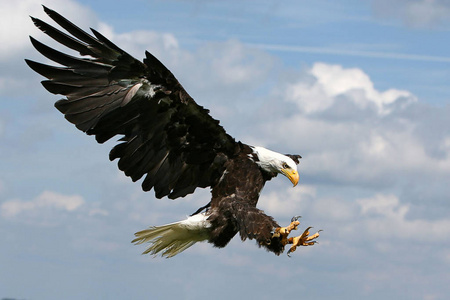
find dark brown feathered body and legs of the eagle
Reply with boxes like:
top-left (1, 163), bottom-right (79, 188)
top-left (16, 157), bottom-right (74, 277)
top-left (208, 145), bottom-right (278, 247)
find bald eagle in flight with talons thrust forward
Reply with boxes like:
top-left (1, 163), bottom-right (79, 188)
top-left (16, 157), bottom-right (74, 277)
top-left (26, 6), bottom-right (318, 257)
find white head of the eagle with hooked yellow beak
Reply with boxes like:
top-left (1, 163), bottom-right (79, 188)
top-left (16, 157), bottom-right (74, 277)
top-left (252, 147), bottom-right (300, 186)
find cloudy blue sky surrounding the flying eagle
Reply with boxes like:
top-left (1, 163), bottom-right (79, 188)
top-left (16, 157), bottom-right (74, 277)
top-left (0, 0), bottom-right (450, 300)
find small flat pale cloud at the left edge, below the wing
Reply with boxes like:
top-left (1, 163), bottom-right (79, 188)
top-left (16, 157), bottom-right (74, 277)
top-left (0, 191), bottom-right (84, 218)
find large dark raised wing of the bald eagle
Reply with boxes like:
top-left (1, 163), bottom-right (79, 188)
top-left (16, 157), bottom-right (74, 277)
top-left (26, 7), bottom-right (237, 199)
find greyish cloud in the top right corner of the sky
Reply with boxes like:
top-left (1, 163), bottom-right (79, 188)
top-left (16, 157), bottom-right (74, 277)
top-left (373, 0), bottom-right (450, 27)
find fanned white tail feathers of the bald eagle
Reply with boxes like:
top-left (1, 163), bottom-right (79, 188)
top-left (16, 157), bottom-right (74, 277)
top-left (132, 213), bottom-right (211, 258)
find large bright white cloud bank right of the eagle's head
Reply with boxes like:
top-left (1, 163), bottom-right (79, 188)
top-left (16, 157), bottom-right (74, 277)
top-left (253, 63), bottom-right (450, 192)
